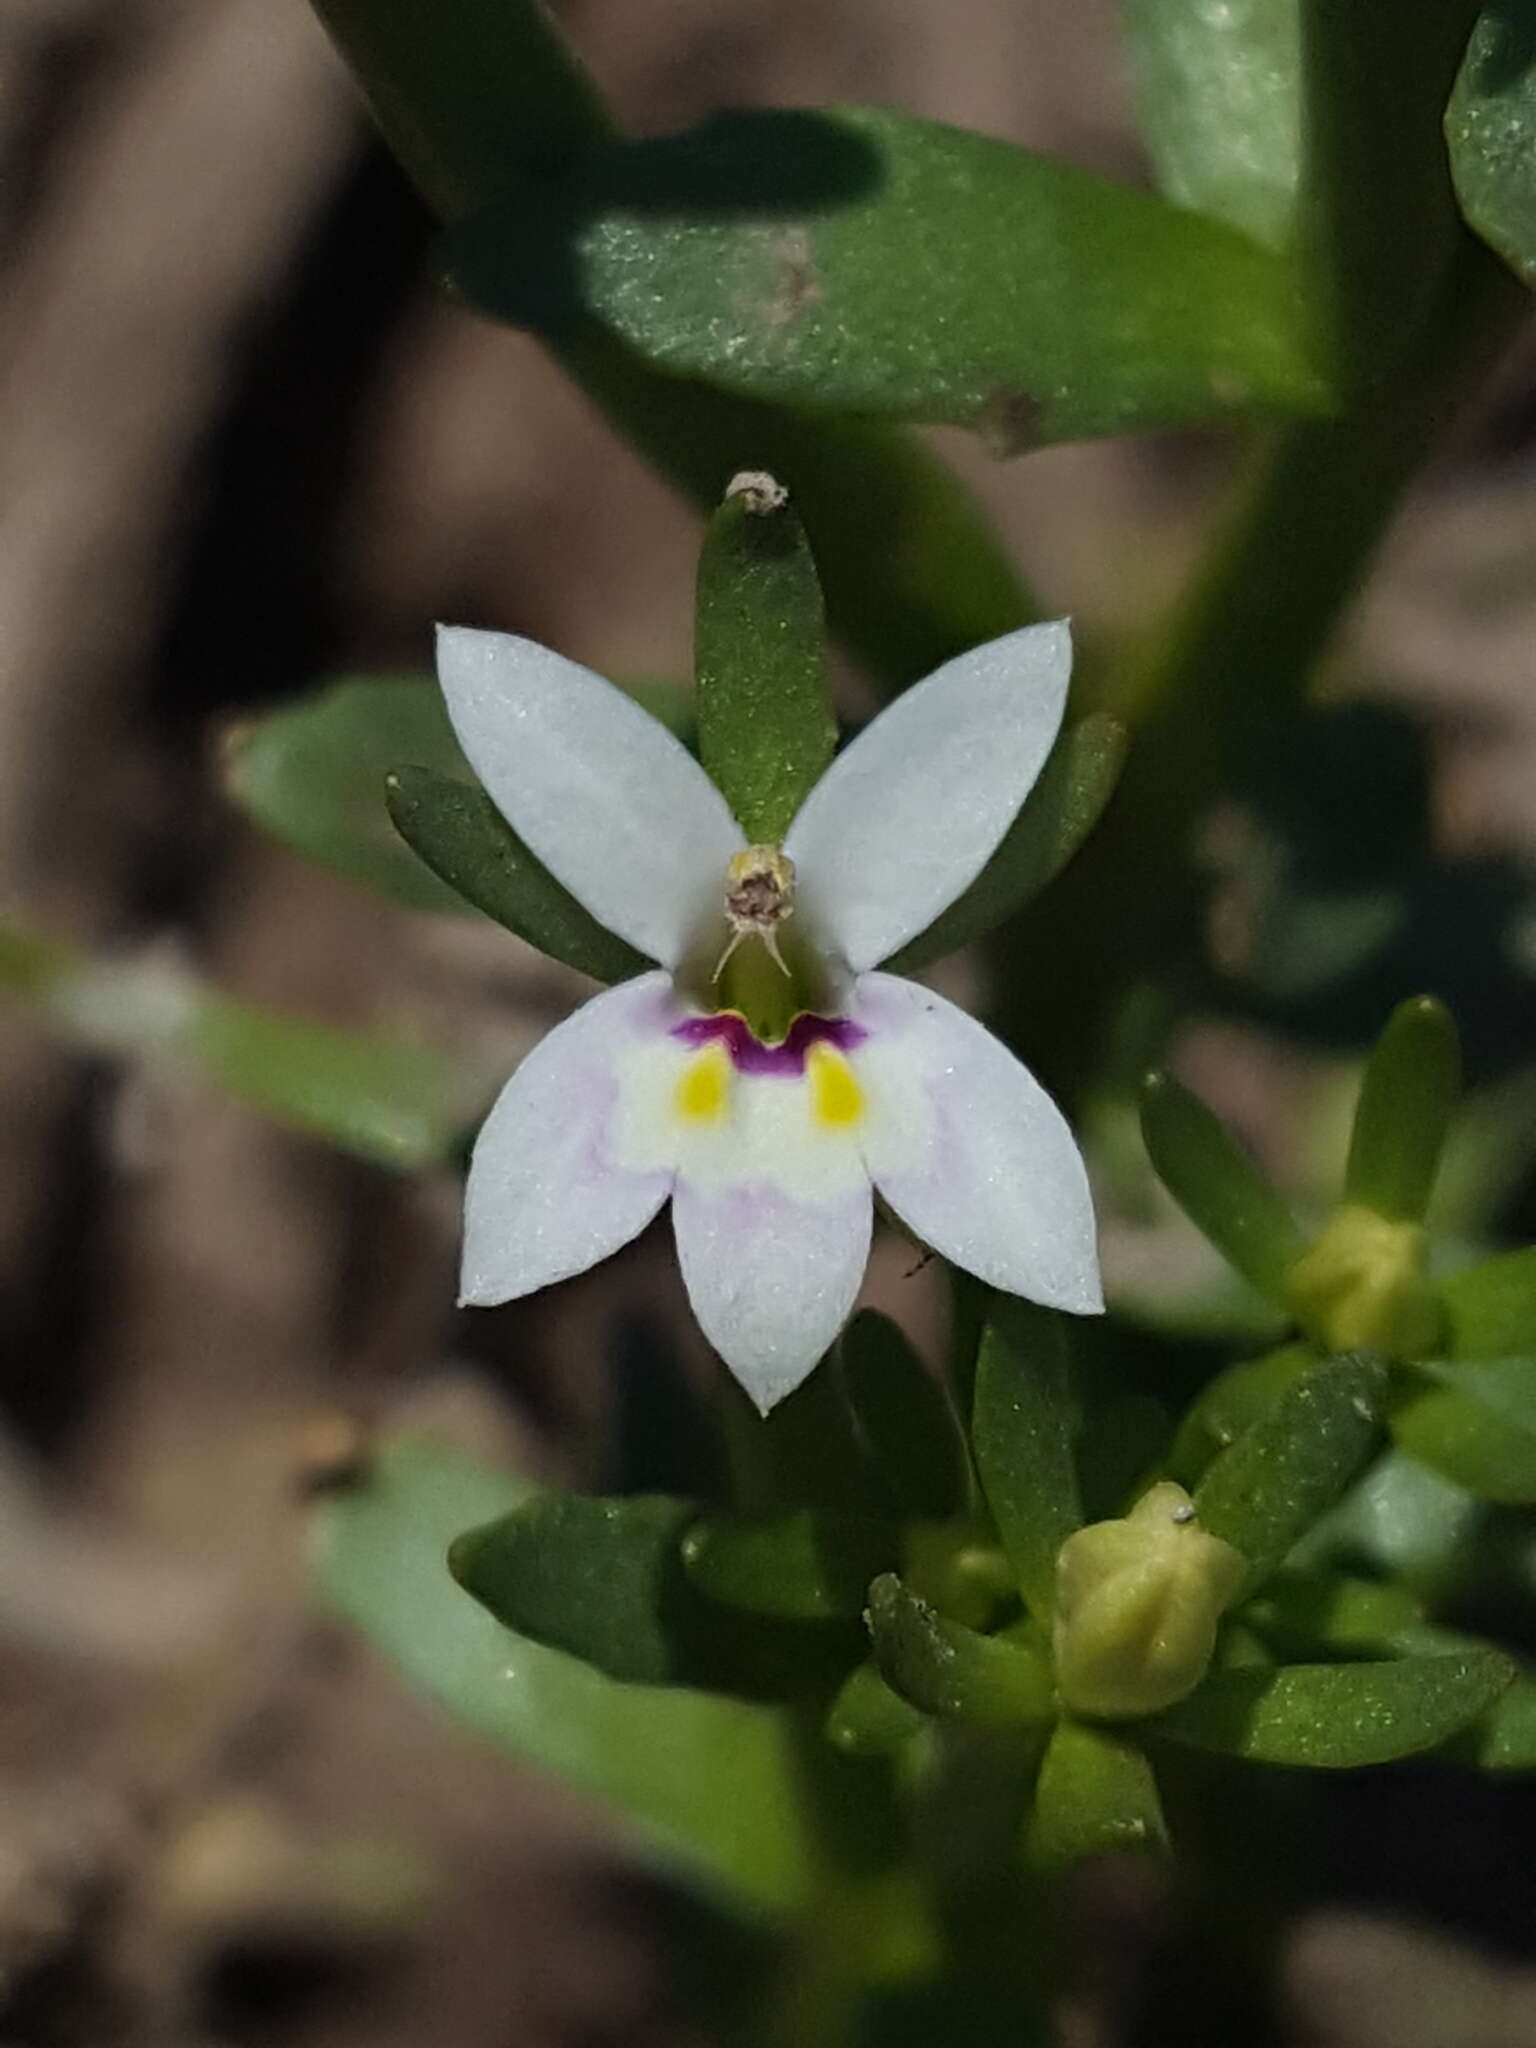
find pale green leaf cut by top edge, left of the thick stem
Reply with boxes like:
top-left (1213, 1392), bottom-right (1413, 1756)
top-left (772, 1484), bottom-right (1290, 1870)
top-left (1120, 0), bottom-right (1300, 248)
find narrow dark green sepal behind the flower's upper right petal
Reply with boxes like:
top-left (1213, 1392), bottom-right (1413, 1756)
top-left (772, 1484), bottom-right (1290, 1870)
top-left (887, 711), bottom-right (1128, 975)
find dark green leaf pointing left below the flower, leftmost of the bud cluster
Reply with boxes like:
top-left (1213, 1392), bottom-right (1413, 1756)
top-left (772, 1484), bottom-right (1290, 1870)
top-left (449, 1493), bottom-right (844, 1698)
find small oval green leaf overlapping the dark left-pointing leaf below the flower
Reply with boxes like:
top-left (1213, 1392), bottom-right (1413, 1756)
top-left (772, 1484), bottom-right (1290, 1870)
top-left (682, 1507), bottom-right (897, 1622)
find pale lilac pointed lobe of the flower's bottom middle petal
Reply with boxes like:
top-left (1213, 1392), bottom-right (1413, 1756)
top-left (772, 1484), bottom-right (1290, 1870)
top-left (672, 1178), bottom-right (874, 1415)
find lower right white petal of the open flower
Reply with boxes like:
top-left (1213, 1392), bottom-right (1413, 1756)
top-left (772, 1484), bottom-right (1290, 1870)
top-left (852, 975), bottom-right (1104, 1315)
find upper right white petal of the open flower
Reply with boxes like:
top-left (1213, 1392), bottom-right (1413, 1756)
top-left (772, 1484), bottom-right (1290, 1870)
top-left (784, 618), bottom-right (1071, 973)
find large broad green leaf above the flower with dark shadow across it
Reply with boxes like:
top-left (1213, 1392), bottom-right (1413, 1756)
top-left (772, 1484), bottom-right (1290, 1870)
top-left (451, 109), bottom-right (1327, 451)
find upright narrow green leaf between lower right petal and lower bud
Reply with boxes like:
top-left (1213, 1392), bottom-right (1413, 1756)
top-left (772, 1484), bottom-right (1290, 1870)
top-left (971, 1298), bottom-right (1083, 1618)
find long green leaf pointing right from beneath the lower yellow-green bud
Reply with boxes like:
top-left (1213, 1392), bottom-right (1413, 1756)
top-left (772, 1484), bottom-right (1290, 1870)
top-left (1145, 1651), bottom-right (1516, 1769)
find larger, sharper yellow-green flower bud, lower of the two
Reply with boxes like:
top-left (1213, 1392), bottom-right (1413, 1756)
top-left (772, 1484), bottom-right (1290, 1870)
top-left (1055, 1479), bottom-right (1247, 1720)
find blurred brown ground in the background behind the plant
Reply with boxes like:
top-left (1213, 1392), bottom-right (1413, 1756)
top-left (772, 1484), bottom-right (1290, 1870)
top-left (0, 0), bottom-right (1536, 2048)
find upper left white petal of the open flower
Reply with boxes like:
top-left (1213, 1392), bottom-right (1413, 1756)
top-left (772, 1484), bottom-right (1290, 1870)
top-left (438, 627), bottom-right (741, 967)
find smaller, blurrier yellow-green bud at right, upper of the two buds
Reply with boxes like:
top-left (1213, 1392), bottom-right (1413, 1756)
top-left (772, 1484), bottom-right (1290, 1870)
top-left (1286, 1202), bottom-right (1444, 1358)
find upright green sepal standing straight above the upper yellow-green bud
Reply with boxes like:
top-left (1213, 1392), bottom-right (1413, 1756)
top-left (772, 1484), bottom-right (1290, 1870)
top-left (1343, 995), bottom-right (1462, 1223)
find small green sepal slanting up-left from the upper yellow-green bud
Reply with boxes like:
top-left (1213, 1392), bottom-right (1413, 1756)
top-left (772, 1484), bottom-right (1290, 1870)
top-left (1141, 1073), bottom-right (1307, 1303)
